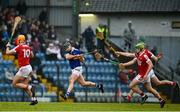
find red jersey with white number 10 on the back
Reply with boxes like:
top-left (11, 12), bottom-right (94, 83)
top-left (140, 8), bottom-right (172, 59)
top-left (14, 44), bottom-right (32, 67)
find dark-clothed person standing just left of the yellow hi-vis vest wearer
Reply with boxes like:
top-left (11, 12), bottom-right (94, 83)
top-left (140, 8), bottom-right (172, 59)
top-left (82, 26), bottom-right (95, 52)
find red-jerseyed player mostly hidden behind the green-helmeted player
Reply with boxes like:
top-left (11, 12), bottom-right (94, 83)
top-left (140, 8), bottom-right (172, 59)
top-left (116, 43), bottom-right (177, 103)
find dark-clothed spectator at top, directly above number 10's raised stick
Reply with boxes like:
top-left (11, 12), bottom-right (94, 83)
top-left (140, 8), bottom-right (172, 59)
top-left (16, 0), bottom-right (27, 15)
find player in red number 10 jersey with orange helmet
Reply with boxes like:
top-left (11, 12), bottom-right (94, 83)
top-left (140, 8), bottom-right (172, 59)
top-left (6, 35), bottom-right (38, 105)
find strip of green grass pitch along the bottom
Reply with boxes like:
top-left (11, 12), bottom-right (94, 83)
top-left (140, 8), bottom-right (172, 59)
top-left (0, 102), bottom-right (180, 112)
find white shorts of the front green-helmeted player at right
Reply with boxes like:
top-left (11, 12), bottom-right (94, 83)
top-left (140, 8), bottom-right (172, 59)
top-left (135, 69), bottom-right (155, 83)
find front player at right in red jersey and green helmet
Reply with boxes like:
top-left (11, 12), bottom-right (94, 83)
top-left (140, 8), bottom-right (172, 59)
top-left (117, 43), bottom-right (165, 108)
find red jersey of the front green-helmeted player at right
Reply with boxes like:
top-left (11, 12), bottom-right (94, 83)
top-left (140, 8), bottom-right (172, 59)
top-left (135, 50), bottom-right (150, 78)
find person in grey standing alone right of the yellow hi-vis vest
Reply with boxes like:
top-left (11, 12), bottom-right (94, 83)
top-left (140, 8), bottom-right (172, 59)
top-left (123, 21), bottom-right (137, 51)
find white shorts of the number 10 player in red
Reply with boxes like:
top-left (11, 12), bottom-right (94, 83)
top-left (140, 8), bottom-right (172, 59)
top-left (17, 65), bottom-right (32, 78)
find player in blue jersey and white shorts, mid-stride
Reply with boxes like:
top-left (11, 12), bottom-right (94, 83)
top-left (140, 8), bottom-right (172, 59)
top-left (63, 42), bottom-right (104, 99)
